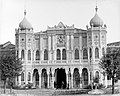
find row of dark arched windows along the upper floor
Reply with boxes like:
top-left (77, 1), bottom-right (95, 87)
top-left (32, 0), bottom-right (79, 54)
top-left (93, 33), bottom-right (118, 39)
top-left (17, 47), bottom-right (105, 60)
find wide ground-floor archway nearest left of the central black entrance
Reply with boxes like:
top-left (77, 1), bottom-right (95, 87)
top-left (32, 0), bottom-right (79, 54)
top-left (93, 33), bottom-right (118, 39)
top-left (41, 69), bottom-right (48, 88)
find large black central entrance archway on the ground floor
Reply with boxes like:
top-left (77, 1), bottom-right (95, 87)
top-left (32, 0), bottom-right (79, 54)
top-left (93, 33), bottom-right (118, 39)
top-left (55, 68), bottom-right (66, 89)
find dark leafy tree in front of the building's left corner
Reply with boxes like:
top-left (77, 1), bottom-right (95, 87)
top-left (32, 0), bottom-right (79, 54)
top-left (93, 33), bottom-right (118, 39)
top-left (0, 54), bottom-right (22, 93)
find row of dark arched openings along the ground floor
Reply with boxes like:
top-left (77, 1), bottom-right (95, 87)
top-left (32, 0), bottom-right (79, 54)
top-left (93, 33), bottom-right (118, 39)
top-left (21, 68), bottom-right (99, 89)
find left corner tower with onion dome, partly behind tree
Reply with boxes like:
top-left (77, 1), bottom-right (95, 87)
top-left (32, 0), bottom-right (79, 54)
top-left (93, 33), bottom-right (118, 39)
top-left (15, 10), bottom-right (34, 85)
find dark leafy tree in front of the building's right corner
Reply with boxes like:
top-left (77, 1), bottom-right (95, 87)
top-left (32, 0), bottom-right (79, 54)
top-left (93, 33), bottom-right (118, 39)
top-left (99, 49), bottom-right (120, 94)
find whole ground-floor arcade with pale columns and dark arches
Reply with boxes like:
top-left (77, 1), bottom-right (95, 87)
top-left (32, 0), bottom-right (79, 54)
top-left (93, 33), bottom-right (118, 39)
top-left (16, 67), bottom-right (106, 89)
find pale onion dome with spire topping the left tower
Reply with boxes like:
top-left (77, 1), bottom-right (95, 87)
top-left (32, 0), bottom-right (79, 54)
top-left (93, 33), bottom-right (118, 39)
top-left (19, 10), bottom-right (33, 29)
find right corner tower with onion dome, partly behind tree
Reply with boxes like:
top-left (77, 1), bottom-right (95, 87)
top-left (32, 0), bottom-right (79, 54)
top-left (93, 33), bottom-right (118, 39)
top-left (87, 6), bottom-right (107, 83)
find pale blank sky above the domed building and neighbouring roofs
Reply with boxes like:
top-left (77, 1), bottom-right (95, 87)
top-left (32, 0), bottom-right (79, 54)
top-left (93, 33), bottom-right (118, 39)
top-left (0, 0), bottom-right (120, 44)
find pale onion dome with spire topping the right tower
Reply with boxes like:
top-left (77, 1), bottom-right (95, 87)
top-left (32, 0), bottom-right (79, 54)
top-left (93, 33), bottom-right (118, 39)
top-left (90, 6), bottom-right (103, 27)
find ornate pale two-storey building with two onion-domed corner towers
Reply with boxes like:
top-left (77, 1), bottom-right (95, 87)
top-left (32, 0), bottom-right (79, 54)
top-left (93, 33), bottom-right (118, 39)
top-left (15, 7), bottom-right (107, 88)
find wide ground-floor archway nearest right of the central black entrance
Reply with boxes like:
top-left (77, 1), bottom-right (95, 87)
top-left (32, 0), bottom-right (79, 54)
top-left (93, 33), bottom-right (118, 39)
top-left (73, 68), bottom-right (80, 88)
